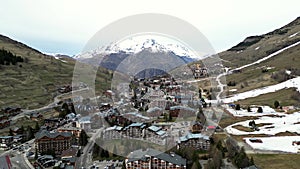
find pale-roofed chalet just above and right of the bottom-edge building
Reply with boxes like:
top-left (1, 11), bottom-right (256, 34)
top-left (178, 133), bottom-right (210, 150)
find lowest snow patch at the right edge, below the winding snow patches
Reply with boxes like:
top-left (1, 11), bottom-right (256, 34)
top-left (244, 136), bottom-right (300, 153)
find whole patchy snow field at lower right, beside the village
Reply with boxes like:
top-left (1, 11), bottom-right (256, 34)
top-left (225, 106), bottom-right (300, 153)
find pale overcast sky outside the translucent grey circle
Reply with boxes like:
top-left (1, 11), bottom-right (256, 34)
top-left (0, 0), bottom-right (300, 55)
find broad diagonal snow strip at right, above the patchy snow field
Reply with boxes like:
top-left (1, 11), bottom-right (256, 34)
top-left (223, 77), bottom-right (300, 103)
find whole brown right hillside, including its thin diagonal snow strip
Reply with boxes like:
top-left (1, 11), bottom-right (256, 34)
top-left (219, 18), bottom-right (300, 103)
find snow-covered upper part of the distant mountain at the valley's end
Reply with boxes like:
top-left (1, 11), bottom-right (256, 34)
top-left (76, 36), bottom-right (199, 74)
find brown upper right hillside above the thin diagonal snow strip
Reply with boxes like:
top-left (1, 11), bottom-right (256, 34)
top-left (219, 17), bottom-right (300, 68)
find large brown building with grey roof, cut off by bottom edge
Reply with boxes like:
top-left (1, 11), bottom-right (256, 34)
top-left (125, 148), bottom-right (186, 169)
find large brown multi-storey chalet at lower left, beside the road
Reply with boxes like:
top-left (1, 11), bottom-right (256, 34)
top-left (35, 130), bottom-right (72, 154)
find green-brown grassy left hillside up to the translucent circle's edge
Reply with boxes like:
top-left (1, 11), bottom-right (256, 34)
top-left (0, 35), bottom-right (109, 108)
